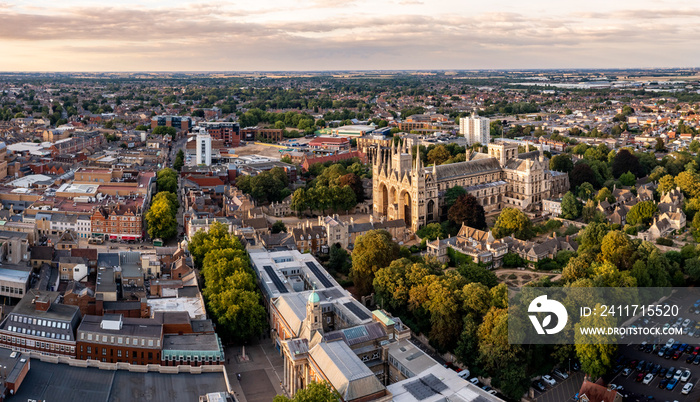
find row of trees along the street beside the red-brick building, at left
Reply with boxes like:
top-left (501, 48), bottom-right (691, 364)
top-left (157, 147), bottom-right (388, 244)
top-left (146, 168), bottom-right (180, 240)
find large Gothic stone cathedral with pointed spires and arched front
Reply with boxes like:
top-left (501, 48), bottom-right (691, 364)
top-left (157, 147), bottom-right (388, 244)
top-left (372, 140), bottom-right (569, 231)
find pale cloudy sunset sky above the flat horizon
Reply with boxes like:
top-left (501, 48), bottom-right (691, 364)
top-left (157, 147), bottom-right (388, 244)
top-left (0, 0), bottom-right (700, 71)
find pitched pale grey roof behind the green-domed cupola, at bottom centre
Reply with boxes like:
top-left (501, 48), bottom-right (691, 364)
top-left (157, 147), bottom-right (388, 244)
top-left (309, 342), bottom-right (384, 401)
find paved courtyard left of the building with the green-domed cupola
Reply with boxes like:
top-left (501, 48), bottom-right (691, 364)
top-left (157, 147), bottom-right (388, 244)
top-left (225, 339), bottom-right (284, 402)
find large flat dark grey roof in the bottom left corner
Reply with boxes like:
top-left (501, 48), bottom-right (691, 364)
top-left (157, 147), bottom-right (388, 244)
top-left (13, 359), bottom-right (227, 402)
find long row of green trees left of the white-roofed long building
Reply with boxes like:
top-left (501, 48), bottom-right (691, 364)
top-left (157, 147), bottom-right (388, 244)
top-left (188, 222), bottom-right (267, 342)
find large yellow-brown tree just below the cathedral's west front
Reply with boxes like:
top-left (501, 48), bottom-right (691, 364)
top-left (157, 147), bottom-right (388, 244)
top-left (350, 230), bottom-right (399, 296)
